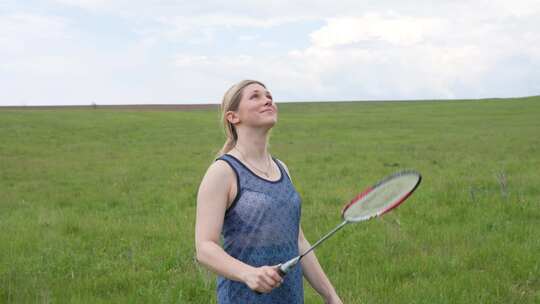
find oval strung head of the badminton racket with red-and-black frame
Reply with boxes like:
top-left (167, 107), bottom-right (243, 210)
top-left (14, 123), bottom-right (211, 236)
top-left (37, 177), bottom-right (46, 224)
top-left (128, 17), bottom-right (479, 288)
top-left (341, 170), bottom-right (422, 222)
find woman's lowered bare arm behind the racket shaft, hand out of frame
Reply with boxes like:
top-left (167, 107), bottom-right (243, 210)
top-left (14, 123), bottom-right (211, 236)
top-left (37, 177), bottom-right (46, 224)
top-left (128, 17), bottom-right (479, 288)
top-left (298, 228), bottom-right (343, 304)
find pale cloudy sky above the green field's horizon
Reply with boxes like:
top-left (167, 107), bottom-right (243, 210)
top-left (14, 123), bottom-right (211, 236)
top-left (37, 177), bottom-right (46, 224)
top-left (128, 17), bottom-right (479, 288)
top-left (0, 0), bottom-right (540, 106)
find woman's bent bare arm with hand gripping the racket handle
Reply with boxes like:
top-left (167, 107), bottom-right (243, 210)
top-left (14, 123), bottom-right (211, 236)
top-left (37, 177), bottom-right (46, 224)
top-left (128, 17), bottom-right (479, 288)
top-left (195, 161), bottom-right (282, 292)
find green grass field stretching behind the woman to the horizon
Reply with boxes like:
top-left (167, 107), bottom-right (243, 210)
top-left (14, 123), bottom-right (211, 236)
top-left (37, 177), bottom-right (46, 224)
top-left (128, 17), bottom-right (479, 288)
top-left (0, 97), bottom-right (540, 303)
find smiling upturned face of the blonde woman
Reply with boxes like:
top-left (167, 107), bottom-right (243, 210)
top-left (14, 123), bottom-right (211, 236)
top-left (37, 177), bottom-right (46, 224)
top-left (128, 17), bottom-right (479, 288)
top-left (229, 83), bottom-right (278, 128)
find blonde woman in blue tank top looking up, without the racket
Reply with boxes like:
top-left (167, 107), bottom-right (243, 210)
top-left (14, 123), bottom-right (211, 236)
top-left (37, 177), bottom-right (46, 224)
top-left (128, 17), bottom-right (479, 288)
top-left (195, 80), bottom-right (342, 304)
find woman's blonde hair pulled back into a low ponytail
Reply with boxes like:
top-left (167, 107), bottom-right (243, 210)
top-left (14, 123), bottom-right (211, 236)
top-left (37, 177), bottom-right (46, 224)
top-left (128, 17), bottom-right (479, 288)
top-left (217, 80), bottom-right (266, 157)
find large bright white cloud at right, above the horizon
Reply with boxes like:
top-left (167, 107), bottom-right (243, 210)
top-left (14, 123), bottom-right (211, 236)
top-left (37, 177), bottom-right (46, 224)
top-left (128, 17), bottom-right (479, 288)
top-left (278, 6), bottom-right (540, 99)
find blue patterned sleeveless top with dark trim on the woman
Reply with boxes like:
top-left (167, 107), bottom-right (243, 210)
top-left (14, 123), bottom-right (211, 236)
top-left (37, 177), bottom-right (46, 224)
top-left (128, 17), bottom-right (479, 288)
top-left (216, 154), bottom-right (304, 304)
